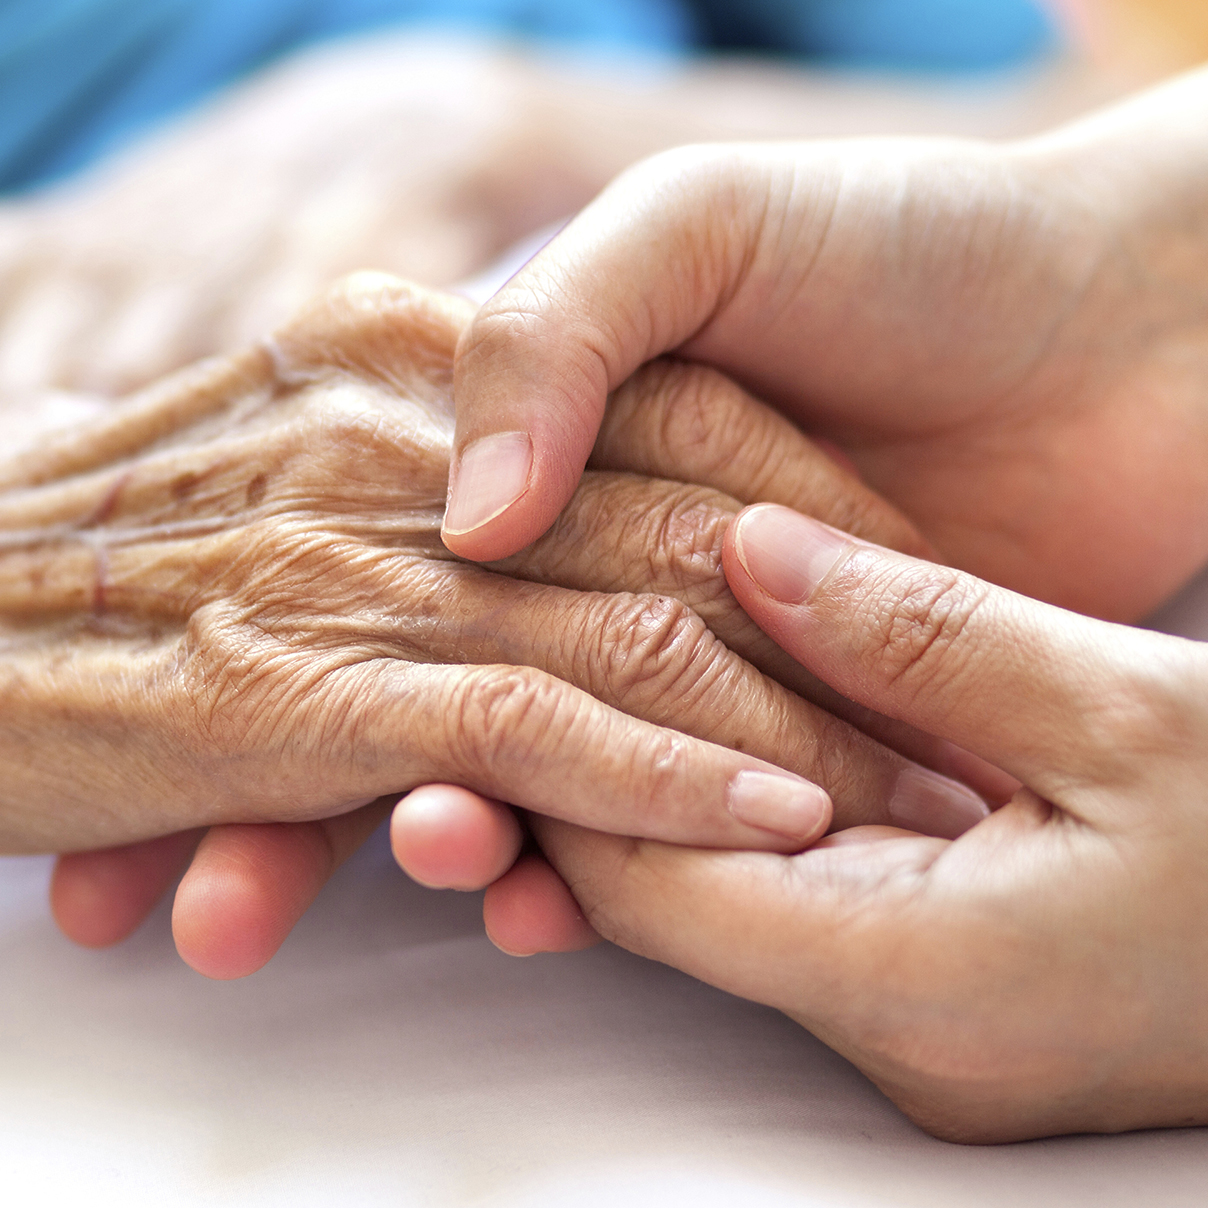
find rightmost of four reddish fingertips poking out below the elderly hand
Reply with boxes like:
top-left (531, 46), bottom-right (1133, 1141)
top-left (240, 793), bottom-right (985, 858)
top-left (482, 855), bottom-right (600, 957)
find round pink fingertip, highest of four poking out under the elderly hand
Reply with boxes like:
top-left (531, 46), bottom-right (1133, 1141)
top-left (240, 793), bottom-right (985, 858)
top-left (390, 784), bottom-right (523, 890)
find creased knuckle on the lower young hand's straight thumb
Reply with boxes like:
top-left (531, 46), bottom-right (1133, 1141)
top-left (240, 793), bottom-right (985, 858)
top-left (865, 565), bottom-right (988, 696)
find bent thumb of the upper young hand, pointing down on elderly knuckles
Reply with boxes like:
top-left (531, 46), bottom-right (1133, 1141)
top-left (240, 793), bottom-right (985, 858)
top-left (443, 147), bottom-right (766, 561)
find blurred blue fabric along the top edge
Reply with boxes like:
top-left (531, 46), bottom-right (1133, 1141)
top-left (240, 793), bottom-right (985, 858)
top-left (0, 0), bottom-right (1052, 190)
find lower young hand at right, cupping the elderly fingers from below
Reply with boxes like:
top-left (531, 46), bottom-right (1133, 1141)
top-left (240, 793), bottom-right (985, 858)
top-left (533, 506), bottom-right (1208, 1142)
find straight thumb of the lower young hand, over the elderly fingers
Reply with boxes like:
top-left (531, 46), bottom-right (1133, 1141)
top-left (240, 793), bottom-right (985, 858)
top-left (724, 505), bottom-right (1204, 800)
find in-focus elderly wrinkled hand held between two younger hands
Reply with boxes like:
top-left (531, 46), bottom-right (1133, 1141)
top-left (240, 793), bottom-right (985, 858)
top-left (0, 274), bottom-right (990, 869)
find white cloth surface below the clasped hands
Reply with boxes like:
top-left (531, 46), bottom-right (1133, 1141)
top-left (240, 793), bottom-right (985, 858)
top-left (7, 567), bottom-right (1208, 1208)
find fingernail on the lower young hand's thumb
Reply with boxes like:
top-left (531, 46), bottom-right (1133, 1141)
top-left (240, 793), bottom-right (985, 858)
top-left (734, 504), bottom-right (853, 604)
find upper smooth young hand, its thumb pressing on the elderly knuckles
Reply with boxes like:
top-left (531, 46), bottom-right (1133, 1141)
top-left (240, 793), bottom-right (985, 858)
top-left (445, 71), bottom-right (1208, 620)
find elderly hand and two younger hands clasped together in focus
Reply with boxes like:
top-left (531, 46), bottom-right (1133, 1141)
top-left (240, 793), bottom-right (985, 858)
top-left (11, 63), bottom-right (1208, 1140)
